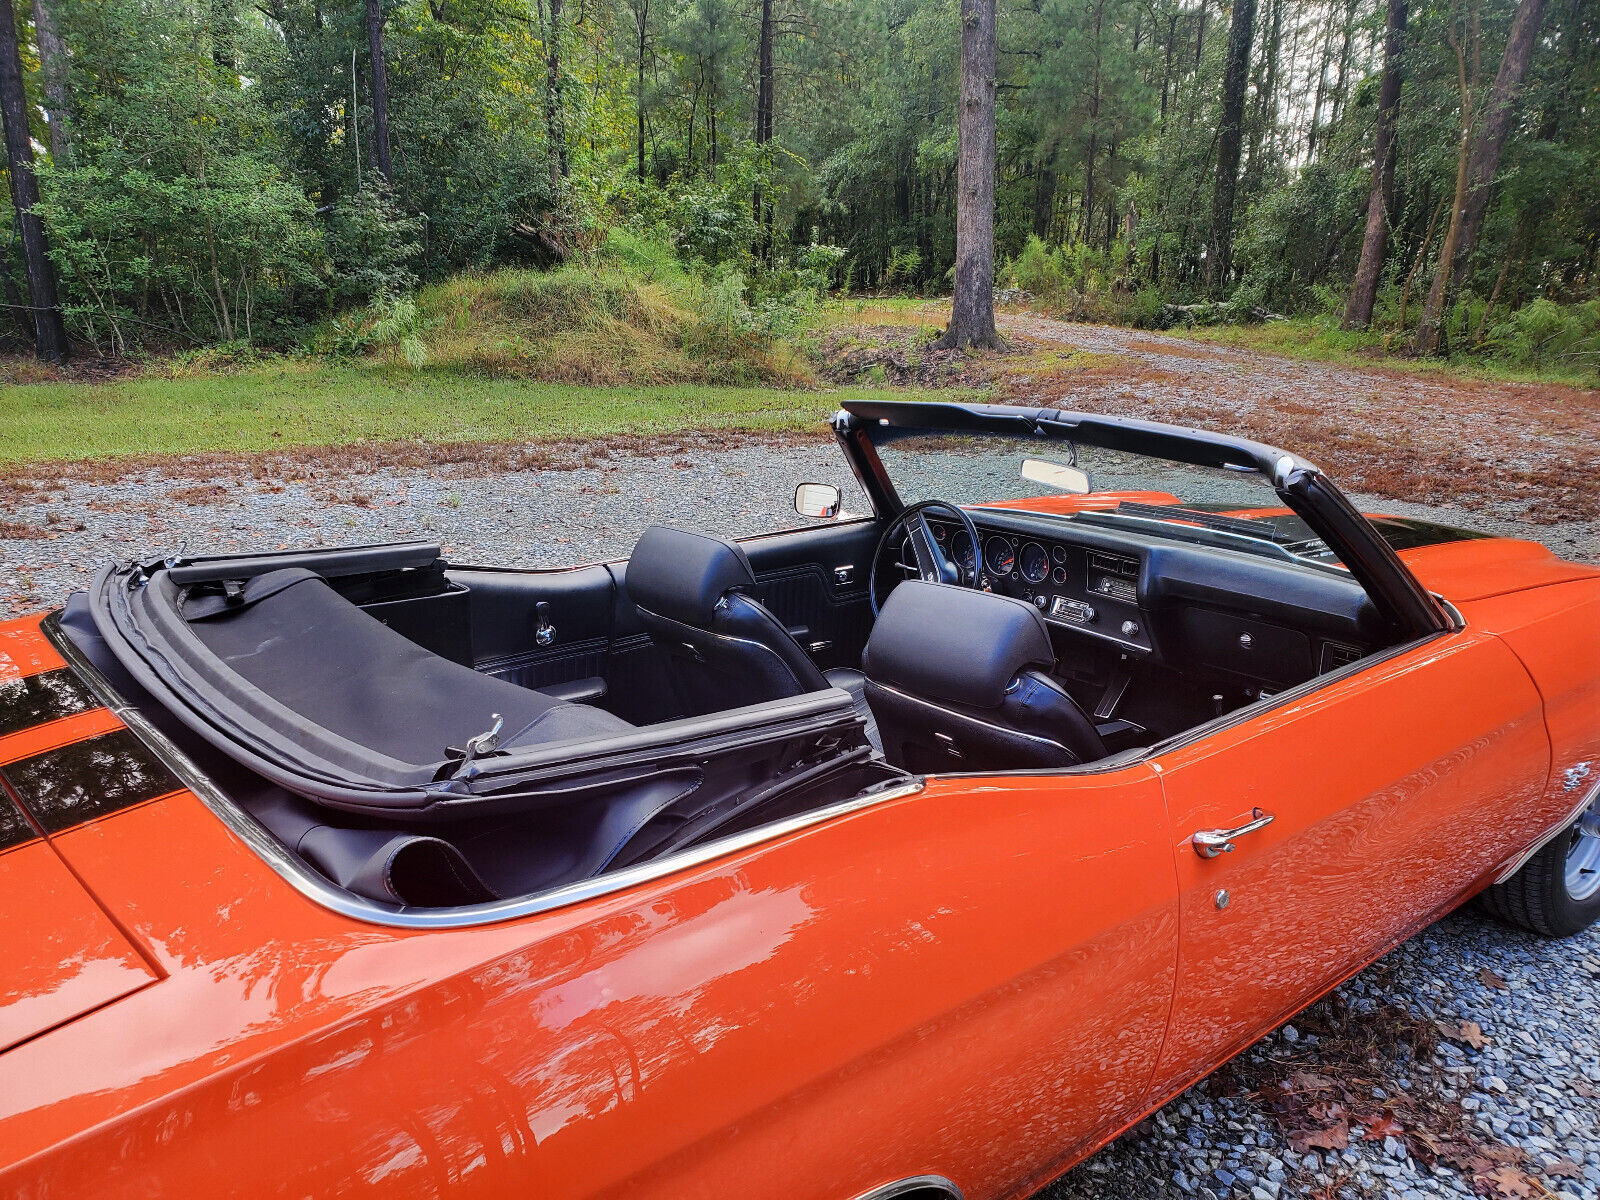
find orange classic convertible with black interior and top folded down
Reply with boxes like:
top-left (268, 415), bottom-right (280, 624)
top-left (0, 403), bottom-right (1600, 1200)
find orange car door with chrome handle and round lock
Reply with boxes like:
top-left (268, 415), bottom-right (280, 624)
top-left (1155, 630), bottom-right (1549, 1094)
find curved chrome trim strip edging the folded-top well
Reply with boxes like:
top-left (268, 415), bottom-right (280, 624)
top-left (40, 613), bottom-right (928, 934)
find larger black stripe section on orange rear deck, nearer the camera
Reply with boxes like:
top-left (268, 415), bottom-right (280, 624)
top-left (0, 730), bottom-right (182, 834)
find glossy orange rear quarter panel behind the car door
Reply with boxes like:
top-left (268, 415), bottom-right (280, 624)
top-left (0, 723), bottom-right (1176, 1200)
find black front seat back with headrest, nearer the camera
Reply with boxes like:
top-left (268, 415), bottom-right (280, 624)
top-left (861, 579), bottom-right (1106, 773)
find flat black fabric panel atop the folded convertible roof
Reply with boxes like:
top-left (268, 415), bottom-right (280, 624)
top-left (182, 566), bottom-right (634, 763)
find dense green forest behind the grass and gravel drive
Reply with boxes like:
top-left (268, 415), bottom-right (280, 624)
top-left (0, 0), bottom-right (1600, 366)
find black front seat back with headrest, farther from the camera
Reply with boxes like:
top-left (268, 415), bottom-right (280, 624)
top-left (626, 525), bottom-right (829, 717)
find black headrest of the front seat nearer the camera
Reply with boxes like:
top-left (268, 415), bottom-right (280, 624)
top-left (861, 579), bottom-right (1056, 709)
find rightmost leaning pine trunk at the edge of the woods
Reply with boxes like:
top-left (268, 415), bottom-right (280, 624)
top-left (1416, 0), bottom-right (1544, 354)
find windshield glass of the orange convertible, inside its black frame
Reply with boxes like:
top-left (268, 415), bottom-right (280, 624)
top-left (872, 426), bottom-right (1338, 566)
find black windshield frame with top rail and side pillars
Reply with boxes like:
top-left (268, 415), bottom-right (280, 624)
top-left (830, 400), bottom-right (1458, 640)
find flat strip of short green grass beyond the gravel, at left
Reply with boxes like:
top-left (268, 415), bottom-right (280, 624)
top-left (0, 362), bottom-right (947, 464)
